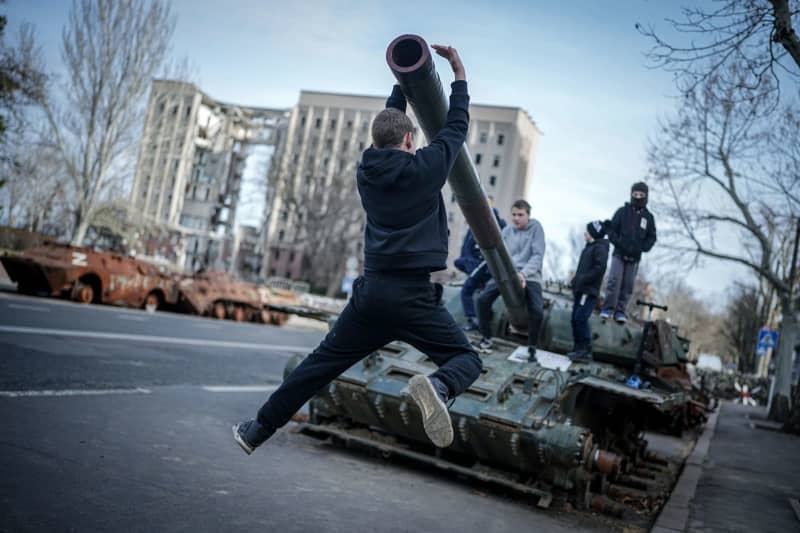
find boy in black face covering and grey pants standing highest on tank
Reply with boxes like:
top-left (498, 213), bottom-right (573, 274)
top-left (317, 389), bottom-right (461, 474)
top-left (600, 181), bottom-right (656, 324)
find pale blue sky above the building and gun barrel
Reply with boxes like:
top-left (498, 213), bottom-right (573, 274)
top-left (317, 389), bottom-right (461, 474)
top-left (4, 0), bottom-right (743, 301)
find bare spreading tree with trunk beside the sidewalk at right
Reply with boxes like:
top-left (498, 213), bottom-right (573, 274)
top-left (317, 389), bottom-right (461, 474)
top-left (648, 63), bottom-right (800, 419)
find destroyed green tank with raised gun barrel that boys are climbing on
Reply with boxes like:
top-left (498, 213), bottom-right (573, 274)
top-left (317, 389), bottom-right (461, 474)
top-left (285, 35), bottom-right (687, 515)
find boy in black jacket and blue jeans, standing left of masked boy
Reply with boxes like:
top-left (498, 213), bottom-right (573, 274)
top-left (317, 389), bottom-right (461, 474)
top-left (567, 220), bottom-right (608, 360)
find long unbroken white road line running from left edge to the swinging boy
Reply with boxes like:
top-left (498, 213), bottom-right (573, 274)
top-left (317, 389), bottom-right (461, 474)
top-left (0, 326), bottom-right (314, 357)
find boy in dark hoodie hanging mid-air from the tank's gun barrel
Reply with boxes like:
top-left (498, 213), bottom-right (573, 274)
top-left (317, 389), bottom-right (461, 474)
top-left (233, 45), bottom-right (481, 454)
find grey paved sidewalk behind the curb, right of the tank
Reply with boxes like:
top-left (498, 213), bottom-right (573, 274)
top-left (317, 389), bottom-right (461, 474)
top-left (652, 402), bottom-right (800, 533)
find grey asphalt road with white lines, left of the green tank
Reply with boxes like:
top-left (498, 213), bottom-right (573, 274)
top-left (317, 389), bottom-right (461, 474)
top-left (0, 294), bottom-right (612, 532)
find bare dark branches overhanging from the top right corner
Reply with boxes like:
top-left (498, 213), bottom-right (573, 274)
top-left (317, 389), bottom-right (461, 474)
top-left (636, 0), bottom-right (800, 98)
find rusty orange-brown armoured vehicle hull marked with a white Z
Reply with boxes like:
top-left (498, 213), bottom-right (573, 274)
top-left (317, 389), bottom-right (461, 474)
top-left (0, 243), bottom-right (177, 310)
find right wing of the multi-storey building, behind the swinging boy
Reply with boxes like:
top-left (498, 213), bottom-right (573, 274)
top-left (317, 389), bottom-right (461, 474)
top-left (263, 91), bottom-right (540, 279)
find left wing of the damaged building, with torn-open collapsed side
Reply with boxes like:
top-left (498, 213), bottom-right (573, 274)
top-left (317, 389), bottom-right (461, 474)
top-left (130, 80), bottom-right (287, 272)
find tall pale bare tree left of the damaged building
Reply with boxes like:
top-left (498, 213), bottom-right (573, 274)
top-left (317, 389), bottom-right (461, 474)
top-left (35, 0), bottom-right (175, 244)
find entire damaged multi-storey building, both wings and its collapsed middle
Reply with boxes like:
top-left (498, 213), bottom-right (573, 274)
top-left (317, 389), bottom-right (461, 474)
top-left (130, 80), bottom-right (540, 286)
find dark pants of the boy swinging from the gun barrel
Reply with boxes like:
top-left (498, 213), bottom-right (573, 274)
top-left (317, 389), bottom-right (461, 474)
top-left (258, 272), bottom-right (482, 428)
